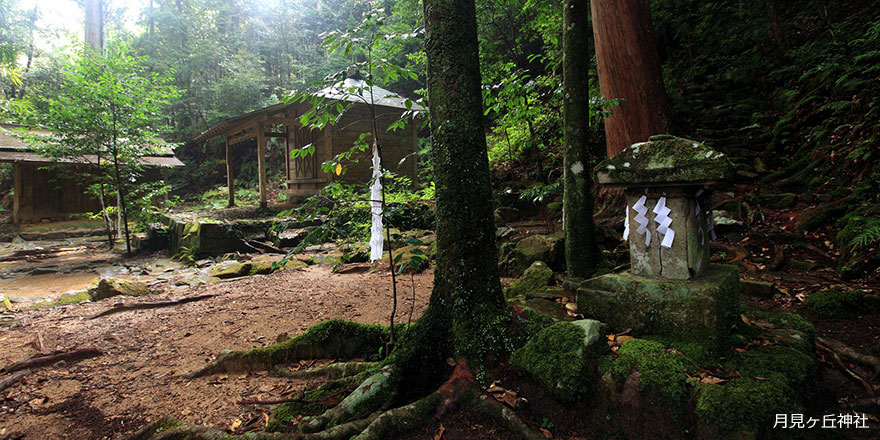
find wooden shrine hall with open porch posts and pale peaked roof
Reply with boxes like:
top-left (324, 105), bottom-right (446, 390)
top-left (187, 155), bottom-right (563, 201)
top-left (193, 78), bottom-right (424, 208)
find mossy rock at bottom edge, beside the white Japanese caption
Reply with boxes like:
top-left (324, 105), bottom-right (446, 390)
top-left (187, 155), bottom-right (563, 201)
top-left (695, 373), bottom-right (803, 439)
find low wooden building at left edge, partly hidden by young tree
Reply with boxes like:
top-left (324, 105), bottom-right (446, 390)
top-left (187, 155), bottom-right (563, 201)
top-left (0, 124), bottom-right (183, 224)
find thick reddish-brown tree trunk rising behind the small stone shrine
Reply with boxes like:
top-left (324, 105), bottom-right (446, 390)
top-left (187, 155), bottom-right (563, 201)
top-left (591, 0), bottom-right (669, 157)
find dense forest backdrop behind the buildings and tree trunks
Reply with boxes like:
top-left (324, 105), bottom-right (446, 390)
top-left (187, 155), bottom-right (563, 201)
top-left (0, 0), bottom-right (880, 274)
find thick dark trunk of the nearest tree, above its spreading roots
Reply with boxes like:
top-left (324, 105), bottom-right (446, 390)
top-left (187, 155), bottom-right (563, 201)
top-left (423, 0), bottom-right (504, 365)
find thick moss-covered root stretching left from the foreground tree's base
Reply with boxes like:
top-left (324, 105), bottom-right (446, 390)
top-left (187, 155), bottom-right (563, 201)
top-left (186, 319), bottom-right (388, 378)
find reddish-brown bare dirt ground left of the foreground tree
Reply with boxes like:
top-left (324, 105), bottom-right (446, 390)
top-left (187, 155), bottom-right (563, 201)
top-left (0, 266), bottom-right (433, 440)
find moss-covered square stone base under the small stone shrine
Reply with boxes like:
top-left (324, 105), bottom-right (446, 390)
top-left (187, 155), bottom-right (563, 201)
top-left (577, 265), bottom-right (742, 349)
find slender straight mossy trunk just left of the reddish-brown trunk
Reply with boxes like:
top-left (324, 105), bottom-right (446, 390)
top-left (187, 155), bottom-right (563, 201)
top-left (562, 0), bottom-right (599, 278)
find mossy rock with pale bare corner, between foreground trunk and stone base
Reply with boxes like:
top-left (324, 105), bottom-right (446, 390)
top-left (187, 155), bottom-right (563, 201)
top-left (511, 319), bottom-right (608, 400)
